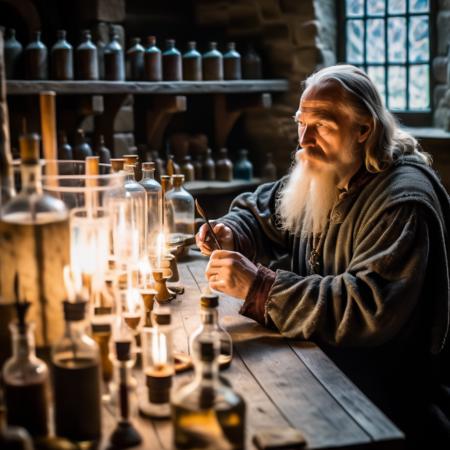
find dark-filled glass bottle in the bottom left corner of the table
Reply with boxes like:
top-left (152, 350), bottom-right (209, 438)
top-left (3, 321), bottom-right (49, 436)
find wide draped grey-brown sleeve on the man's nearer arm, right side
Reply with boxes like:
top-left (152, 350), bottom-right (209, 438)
top-left (265, 205), bottom-right (430, 346)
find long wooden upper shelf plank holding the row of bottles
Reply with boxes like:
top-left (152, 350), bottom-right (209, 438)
top-left (7, 79), bottom-right (288, 95)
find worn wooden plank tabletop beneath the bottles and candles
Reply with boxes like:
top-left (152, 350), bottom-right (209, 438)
top-left (103, 251), bottom-right (403, 450)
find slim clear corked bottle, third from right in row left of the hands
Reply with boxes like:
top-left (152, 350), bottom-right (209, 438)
top-left (140, 162), bottom-right (162, 258)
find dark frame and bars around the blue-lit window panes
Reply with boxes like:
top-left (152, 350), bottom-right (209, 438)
top-left (336, 0), bottom-right (437, 127)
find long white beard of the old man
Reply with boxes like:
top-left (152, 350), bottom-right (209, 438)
top-left (277, 161), bottom-right (338, 235)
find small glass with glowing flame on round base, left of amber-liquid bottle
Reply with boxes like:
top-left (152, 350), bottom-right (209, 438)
top-left (138, 307), bottom-right (175, 418)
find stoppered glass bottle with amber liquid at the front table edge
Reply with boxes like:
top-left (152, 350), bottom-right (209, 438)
top-left (172, 340), bottom-right (246, 450)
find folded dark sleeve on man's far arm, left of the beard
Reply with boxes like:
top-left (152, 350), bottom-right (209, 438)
top-left (219, 179), bottom-right (289, 266)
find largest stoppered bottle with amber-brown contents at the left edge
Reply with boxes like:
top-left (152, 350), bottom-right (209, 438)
top-left (0, 134), bottom-right (69, 347)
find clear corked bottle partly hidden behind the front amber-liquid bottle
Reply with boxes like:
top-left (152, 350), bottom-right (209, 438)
top-left (189, 294), bottom-right (233, 369)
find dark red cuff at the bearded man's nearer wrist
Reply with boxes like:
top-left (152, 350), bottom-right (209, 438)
top-left (239, 264), bottom-right (276, 325)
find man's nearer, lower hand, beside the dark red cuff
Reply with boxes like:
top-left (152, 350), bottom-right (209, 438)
top-left (206, 250), bottom-right (258, 300)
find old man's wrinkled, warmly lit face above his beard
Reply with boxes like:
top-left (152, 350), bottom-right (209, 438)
top-left (295, 85), bottom-right (366, 185)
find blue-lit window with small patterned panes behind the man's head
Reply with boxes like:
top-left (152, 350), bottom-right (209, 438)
top-left (341, 0), bottom-right (431, 113)
